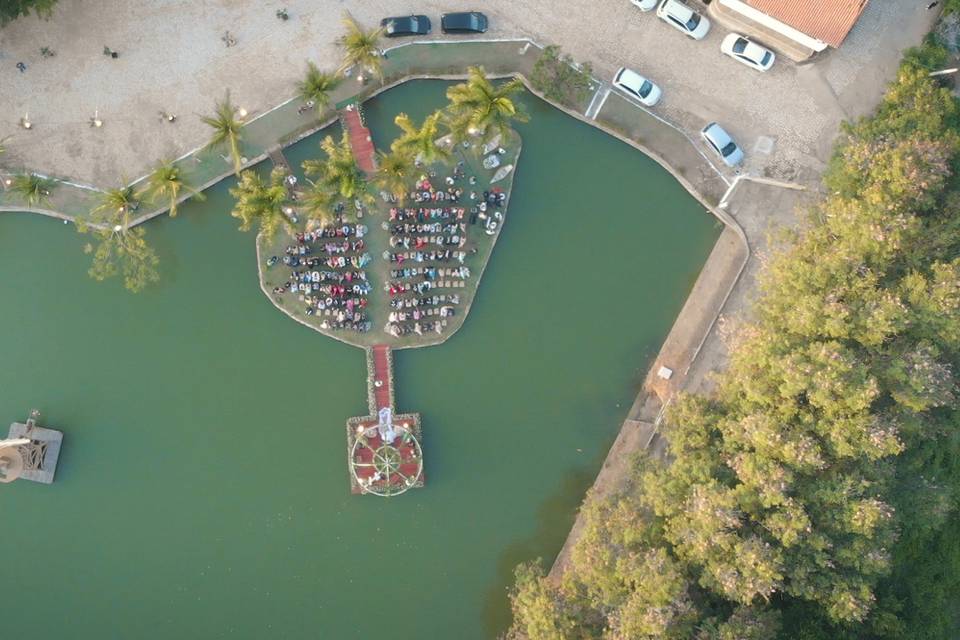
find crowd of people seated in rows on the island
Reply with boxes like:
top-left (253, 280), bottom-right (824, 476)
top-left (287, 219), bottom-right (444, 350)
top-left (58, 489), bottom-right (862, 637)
top-left (267, 156), bottom-right (507, 337)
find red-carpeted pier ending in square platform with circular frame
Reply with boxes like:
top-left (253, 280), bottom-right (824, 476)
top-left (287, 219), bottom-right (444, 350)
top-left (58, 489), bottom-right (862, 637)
top-left (347, 344), bottom-right (424, 497)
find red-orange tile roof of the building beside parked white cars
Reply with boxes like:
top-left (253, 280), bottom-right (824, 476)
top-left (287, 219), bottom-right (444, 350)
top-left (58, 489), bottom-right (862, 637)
top-left (744, 0), bottom-right (869, 47)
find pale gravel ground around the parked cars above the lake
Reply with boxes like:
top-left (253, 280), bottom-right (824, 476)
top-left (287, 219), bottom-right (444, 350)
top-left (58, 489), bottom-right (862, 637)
top-left (0, 0), bottom-right (935, 187)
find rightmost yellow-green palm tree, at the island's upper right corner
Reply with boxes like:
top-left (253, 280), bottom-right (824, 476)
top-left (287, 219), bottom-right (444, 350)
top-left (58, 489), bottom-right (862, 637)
top-left (447, 67), bottom-right (529, 135)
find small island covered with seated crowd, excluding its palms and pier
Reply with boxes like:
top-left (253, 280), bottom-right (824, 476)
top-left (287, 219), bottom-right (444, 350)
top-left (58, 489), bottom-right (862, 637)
top-left (257, 104), bottom-right (520, 349)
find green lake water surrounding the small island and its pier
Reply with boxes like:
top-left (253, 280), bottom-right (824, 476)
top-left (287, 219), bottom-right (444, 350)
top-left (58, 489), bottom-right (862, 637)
top-left (0, 83), bottom-right (719, 640)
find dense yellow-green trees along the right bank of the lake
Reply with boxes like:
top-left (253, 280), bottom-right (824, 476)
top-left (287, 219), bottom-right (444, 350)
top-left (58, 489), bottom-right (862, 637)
top-left (512, 53), bottom-right (960, 640)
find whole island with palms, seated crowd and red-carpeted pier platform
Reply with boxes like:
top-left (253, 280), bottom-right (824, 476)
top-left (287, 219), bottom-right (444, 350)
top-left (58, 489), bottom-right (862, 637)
top-left (238, 67), bottom-right (526, 497)
